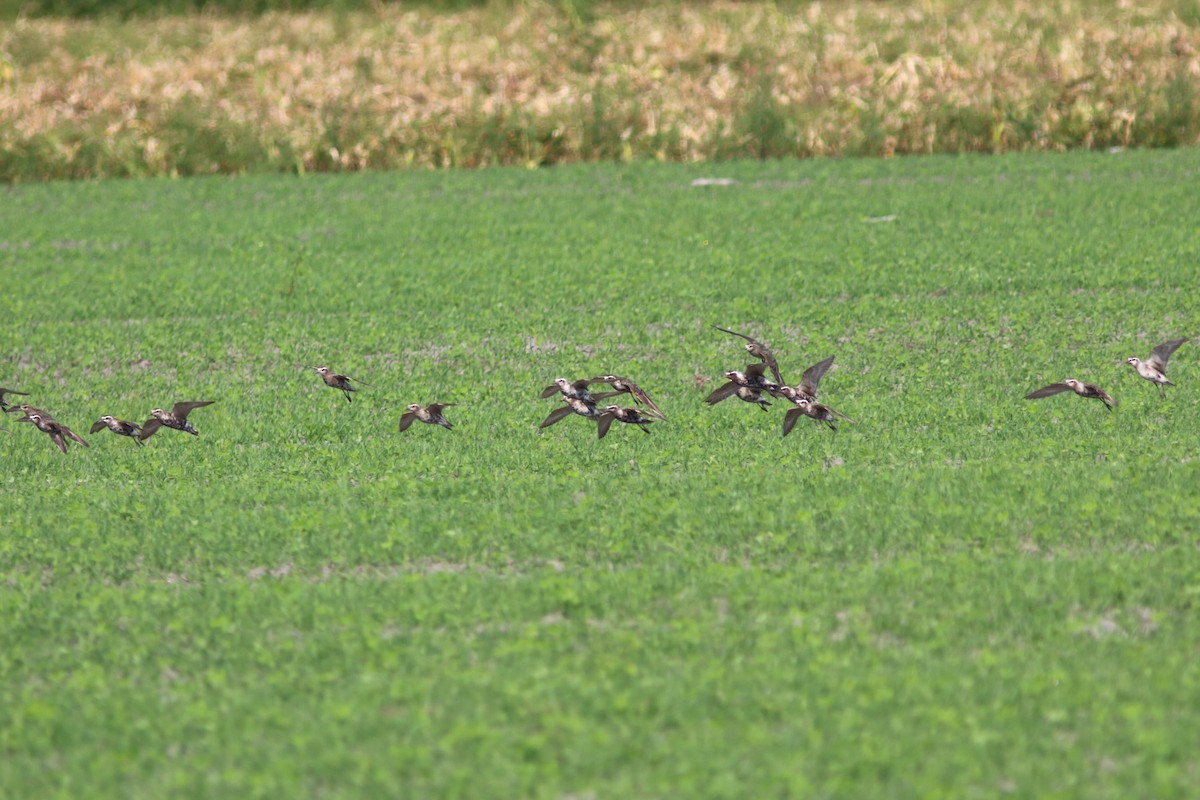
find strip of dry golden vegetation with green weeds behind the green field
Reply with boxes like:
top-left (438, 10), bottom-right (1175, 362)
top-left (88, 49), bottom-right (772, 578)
top-left (0, 0), bottom-right (1200, 180)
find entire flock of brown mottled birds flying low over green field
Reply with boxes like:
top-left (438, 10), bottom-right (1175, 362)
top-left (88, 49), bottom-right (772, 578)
top-left (0, 325), bottom-right (1187, 453)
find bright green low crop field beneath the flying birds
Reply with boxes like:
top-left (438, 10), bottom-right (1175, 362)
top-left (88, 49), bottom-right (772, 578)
top-left (0, 150), bottom-right (1200, 800)
